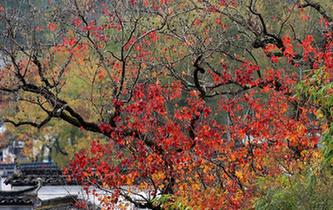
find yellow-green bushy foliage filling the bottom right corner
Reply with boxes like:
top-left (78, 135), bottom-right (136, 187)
top-left (255, 167), bottom-right (333, 210)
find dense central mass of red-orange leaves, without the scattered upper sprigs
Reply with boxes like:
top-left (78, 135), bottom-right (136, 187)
top-left (71, 77), bottom-right (317, 206)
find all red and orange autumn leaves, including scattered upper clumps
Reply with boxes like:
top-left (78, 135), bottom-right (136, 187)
top-left (64, 4), bottom-right (333, 209)
